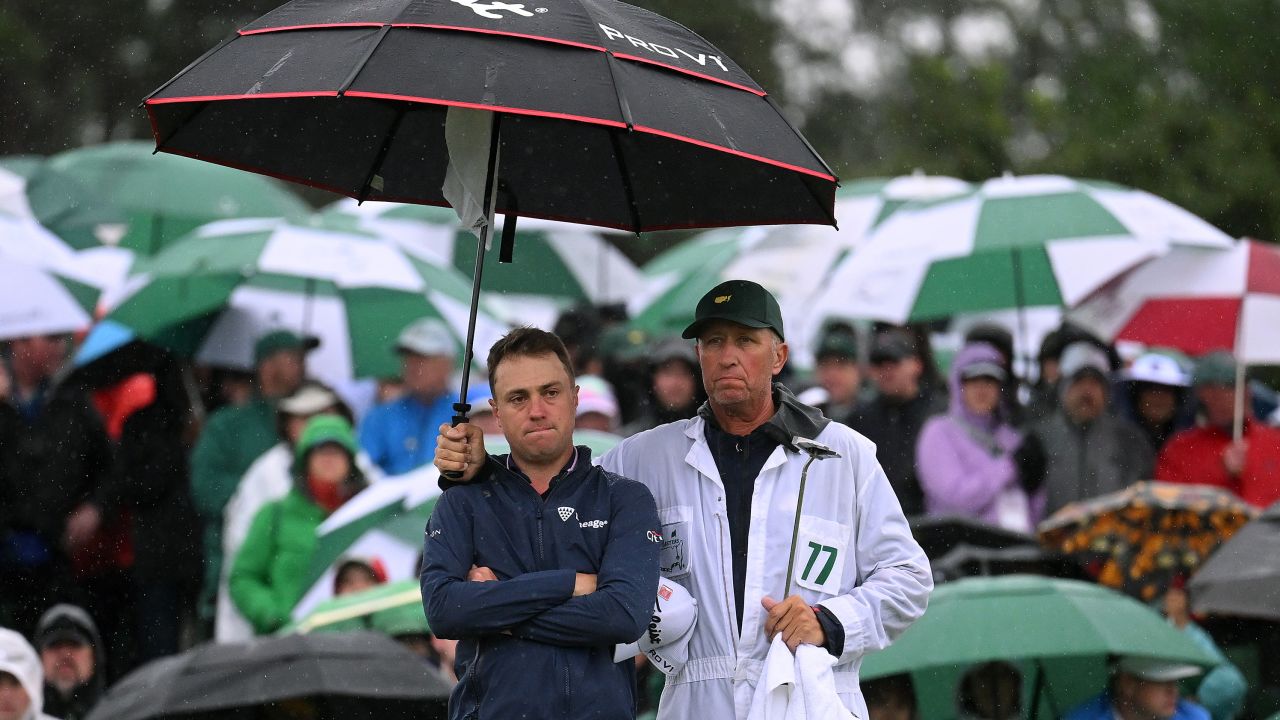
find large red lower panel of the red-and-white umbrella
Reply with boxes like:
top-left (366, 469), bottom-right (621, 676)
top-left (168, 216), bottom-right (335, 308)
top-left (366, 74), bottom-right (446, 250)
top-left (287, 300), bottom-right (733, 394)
top-left (1116, 297), bottom-right (1243, 355)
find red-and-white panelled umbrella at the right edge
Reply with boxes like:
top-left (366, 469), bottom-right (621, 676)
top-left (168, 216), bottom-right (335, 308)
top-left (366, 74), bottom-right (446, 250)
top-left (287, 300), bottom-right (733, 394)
top-left (1070, 240), bottom-right (1280, 364)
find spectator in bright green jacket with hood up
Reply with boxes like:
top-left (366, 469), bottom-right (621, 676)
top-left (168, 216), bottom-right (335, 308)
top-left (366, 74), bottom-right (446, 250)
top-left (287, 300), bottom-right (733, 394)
top-left (230, 415), bottom-right (365, 634)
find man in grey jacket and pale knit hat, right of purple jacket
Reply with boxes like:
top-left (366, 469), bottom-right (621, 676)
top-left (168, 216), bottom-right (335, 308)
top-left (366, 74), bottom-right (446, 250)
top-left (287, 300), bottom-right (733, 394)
top-left (1015, 342), bottom-right (1155, 515)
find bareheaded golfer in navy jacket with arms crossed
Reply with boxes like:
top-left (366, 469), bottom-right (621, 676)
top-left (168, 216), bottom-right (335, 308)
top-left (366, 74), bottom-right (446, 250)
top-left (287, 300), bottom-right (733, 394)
top-left (422, 328), bottom-right (662, 720)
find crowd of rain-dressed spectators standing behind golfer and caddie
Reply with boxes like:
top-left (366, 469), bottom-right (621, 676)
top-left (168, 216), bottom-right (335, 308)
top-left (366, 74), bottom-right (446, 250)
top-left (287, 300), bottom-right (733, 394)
top-left (0, 303), bottom-right (1280, 717)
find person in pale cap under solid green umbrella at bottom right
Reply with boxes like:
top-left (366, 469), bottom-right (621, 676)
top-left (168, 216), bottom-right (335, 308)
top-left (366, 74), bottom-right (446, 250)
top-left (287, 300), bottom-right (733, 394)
top-left (1066, 656), bottom-right (1210, 720)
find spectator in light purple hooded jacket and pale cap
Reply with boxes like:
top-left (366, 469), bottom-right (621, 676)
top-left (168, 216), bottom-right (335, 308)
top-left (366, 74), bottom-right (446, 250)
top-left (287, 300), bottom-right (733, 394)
top-left (915, 342), bottom-right (1043, 532)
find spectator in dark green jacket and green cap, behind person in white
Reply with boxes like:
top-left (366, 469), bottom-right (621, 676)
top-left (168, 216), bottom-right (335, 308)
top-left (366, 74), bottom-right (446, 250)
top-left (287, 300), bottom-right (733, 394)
top-left (191, 331), bottom-right (320, 625)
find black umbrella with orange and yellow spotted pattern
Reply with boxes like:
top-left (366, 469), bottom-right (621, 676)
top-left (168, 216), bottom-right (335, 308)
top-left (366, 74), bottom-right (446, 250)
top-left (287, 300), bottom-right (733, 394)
top-left (1039, 482), bottom-right (1254, 601)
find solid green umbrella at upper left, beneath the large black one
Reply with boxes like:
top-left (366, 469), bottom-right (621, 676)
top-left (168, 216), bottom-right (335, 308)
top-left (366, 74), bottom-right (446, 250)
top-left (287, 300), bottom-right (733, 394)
top-left (47, 141), bottom-right (311, 255)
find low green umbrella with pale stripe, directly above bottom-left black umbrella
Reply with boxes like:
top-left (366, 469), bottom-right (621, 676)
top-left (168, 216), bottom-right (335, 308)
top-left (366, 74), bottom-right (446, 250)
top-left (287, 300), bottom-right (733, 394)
top-left (280, 579), bottom-right (431, 635)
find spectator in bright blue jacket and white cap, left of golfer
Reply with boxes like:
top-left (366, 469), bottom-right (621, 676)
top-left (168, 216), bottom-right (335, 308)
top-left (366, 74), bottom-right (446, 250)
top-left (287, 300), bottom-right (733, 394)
top-left (360, 318), bottom-right (458, 475)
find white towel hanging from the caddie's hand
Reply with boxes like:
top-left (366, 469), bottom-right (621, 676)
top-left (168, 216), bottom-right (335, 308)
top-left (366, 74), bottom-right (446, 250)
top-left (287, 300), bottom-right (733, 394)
top-left (746, 633), bottom-right (858, 720)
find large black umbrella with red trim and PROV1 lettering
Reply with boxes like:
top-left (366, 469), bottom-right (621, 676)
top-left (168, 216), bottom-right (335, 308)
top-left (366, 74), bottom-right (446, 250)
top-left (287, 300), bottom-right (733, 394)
top-left (146, 0), bottom-right (836, 425)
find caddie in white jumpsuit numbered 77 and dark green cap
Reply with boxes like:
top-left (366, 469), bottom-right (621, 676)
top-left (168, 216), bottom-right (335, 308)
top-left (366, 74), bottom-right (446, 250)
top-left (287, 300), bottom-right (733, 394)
top-left (436, 281), bottom-right (933, 720)
